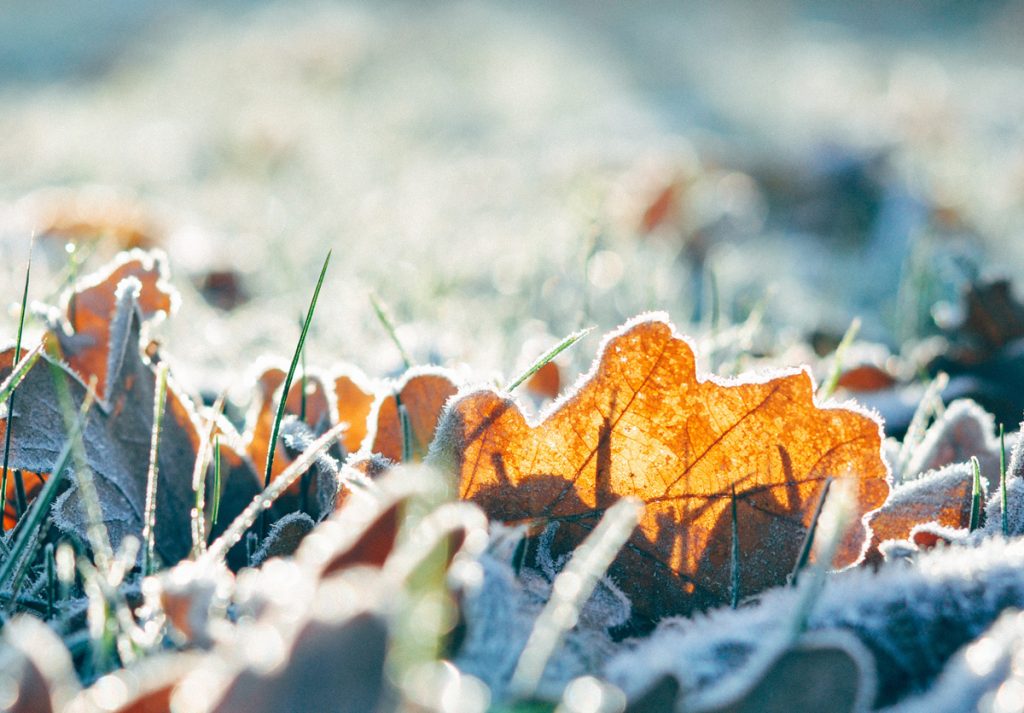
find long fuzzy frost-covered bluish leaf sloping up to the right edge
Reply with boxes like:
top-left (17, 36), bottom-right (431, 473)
top-left (604, 538), bottom-right (1024, 705)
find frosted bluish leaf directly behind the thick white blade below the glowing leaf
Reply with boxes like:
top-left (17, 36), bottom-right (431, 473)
top-left (455, 536), bottom-right (629, 702)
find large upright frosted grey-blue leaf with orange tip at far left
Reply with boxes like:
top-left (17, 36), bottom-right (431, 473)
top-left (0, 260), bottom-right (258, 562)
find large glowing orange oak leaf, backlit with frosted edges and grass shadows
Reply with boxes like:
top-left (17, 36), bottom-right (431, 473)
top-left (434, 317), bottom-right (889, 618)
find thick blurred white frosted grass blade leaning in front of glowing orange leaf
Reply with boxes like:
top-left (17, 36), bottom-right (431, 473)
top-left (509, 498), bottom-right (643, 699)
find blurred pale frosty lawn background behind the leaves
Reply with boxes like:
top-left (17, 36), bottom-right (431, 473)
top-left (0, 0), bottom-right (1024, 401)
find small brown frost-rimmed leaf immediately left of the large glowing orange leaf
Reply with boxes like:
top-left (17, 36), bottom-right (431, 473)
top-left (370, 369), bottom-right (459, 463)
